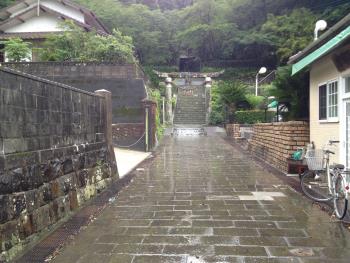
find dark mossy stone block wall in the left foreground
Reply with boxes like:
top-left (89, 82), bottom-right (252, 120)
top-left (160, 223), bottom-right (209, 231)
top-left (0, 68), bottom-right (118, 262)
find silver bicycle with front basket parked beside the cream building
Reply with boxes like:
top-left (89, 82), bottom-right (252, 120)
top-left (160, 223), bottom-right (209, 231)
top-left (300, 140), bottom-right (350, 219)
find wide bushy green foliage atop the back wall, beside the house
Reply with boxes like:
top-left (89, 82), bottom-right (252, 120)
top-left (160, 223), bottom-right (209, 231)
top-left (40, 22), bottom-right (134, 63)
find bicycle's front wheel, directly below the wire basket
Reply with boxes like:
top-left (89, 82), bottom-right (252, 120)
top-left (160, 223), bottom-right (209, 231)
top-left (300, 171), bottom-right (333, 202)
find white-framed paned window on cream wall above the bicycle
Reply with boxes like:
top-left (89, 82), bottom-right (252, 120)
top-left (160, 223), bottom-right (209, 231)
top-left (319, 81), bottom-right (338, 120)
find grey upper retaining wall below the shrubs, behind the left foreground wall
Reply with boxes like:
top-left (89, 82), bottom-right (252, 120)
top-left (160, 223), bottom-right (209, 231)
top-left (4, 62), bottom-right (147, 123)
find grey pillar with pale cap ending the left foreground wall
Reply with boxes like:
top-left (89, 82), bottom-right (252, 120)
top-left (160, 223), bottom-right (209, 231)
top-left (95, 89), bottom-right (119, 179)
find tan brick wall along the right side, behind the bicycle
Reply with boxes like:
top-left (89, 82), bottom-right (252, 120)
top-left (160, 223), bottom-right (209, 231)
top-left (248, 121), bottom-right (310, 172)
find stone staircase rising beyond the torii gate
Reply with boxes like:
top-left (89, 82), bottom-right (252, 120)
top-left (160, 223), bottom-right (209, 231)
top-left (174, 86), bottom-right (206, 126)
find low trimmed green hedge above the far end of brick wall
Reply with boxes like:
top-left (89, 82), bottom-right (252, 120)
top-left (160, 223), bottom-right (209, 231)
top-left (234, 110), bottom-right (276, 124)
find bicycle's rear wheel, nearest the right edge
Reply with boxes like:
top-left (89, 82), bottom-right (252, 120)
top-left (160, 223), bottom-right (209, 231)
top-left (333, 174), bottom-right (348, 219)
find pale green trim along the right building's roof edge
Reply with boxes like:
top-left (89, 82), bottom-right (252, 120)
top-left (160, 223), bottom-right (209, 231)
top-left (292, 26), bottom-right (350, 76)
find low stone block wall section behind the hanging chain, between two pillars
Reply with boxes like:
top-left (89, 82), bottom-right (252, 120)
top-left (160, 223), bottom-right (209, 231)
top-left (113, 123), bottom-right (145, 150)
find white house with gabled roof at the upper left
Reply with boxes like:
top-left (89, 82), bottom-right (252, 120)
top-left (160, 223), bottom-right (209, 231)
top-left (0, 0), bottom-right (109, 62)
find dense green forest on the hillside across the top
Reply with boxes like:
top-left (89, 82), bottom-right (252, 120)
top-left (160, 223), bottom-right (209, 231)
top-left (69, 0), bottom-right (350, 66)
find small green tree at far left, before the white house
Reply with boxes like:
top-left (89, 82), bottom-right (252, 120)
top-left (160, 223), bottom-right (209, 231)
top-left (1, 38), bottom-right (32, 62)
